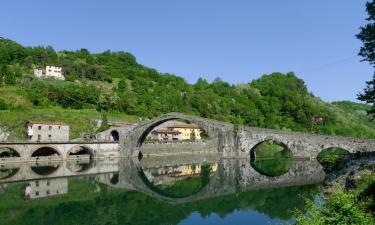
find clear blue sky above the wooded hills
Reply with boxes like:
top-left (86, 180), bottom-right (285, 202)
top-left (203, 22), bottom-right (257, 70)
top-left (0, 0), bottom-right (373, 101)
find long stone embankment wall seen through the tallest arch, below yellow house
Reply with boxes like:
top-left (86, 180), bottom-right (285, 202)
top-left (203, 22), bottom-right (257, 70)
top-left (140, 139), bottom-right (218, 157)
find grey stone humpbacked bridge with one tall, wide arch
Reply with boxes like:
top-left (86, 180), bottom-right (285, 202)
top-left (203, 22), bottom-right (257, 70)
top-left (119, 113), bottom-right (375, 158)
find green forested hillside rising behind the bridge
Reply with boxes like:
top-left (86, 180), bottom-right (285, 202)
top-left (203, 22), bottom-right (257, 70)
top-left (0, 39), bottom-right (375, 141)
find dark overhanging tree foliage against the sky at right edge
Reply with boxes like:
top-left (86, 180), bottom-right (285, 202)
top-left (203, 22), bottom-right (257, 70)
top-left (357, 0), bottom-right (375, 119)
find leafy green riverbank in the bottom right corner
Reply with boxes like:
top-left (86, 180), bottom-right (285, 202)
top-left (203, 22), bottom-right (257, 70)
top-left (296, 157), bottom-right (375, 225)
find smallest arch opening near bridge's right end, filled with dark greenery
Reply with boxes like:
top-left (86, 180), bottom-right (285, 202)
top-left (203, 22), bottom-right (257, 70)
top-left (317, 147), bottom-right (351, 172)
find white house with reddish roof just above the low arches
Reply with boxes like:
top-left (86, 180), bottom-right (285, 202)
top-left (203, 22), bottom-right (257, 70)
top-left (27, 121), bottom-right (69, 142)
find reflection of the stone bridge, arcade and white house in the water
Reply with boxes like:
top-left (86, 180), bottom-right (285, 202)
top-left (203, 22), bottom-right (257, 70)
top-left (0, 155), bottom-right (325, 204)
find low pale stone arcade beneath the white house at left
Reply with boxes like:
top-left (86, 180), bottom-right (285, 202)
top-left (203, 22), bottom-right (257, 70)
top-left (0, 141), bottom-right (119, 162)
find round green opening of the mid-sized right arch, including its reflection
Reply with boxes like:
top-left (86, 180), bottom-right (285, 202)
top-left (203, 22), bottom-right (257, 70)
top-left (250, 140), bottom-right (293, 177)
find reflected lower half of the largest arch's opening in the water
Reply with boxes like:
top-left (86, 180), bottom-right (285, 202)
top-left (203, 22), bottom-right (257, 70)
top-left (138, 163), bottom-right (218, 198)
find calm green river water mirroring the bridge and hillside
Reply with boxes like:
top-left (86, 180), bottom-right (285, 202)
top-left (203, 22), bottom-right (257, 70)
top-left (0, 155), bottom-right (325, 225)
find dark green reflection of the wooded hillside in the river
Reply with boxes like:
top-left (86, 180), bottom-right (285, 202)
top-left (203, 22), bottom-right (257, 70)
top-left (0, 179), bottom-right (319, 225)
